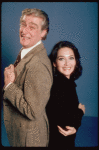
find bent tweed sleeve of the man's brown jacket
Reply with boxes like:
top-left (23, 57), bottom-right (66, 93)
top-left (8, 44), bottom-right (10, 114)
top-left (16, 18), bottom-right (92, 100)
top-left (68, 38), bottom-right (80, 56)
top-left (4, 59), bottom-right (52, 120)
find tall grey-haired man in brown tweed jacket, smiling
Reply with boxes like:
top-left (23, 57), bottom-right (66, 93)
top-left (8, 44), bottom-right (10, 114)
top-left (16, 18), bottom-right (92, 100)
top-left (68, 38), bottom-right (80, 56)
top-left (3, 9), bottom-right (53, 147)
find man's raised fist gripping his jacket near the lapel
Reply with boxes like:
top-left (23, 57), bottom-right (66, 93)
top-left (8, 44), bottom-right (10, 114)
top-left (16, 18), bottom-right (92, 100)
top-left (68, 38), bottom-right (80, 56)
top-left (4, 64), bottom-right (15, 87)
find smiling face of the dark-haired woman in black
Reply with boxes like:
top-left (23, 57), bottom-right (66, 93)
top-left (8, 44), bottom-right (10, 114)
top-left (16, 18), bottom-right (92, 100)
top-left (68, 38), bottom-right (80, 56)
top-left (53, 47), bottom-right (76, 79)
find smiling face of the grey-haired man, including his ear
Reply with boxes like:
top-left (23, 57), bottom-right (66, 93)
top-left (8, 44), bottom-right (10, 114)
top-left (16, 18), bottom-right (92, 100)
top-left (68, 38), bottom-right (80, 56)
top-left (19, 15), bottom-right (46, 48)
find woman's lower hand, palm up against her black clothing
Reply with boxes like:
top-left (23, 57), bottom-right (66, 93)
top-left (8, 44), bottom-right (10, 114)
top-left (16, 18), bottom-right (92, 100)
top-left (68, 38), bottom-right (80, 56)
top-left (57, 126), bottom-right (77, 136)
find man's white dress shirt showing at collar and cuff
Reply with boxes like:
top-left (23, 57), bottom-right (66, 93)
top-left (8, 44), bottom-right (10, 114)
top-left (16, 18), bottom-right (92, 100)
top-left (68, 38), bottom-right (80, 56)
top-left (4, 40), bottom-right (41, 90)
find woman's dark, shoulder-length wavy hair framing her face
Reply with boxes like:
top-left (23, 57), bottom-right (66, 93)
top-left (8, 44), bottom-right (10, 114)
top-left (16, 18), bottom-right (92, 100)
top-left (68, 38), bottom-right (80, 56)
top-left (49, 41), bottom-right (82, 80)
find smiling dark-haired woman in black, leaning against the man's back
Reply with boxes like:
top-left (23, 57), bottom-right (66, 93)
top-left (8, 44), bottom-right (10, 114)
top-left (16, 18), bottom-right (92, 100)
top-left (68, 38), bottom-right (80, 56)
top-left (46, 41), bottom-right (85, 148)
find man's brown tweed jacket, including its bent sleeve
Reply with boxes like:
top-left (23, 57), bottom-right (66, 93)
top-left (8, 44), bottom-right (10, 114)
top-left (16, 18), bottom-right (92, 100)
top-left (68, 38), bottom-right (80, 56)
top-left (3, 43), bottom-right (53, 147)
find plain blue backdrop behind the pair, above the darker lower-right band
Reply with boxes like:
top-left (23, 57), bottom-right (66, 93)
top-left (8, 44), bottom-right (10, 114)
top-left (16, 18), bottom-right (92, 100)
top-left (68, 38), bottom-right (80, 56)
top-left (1, 2), bottom-right (98, 147)
